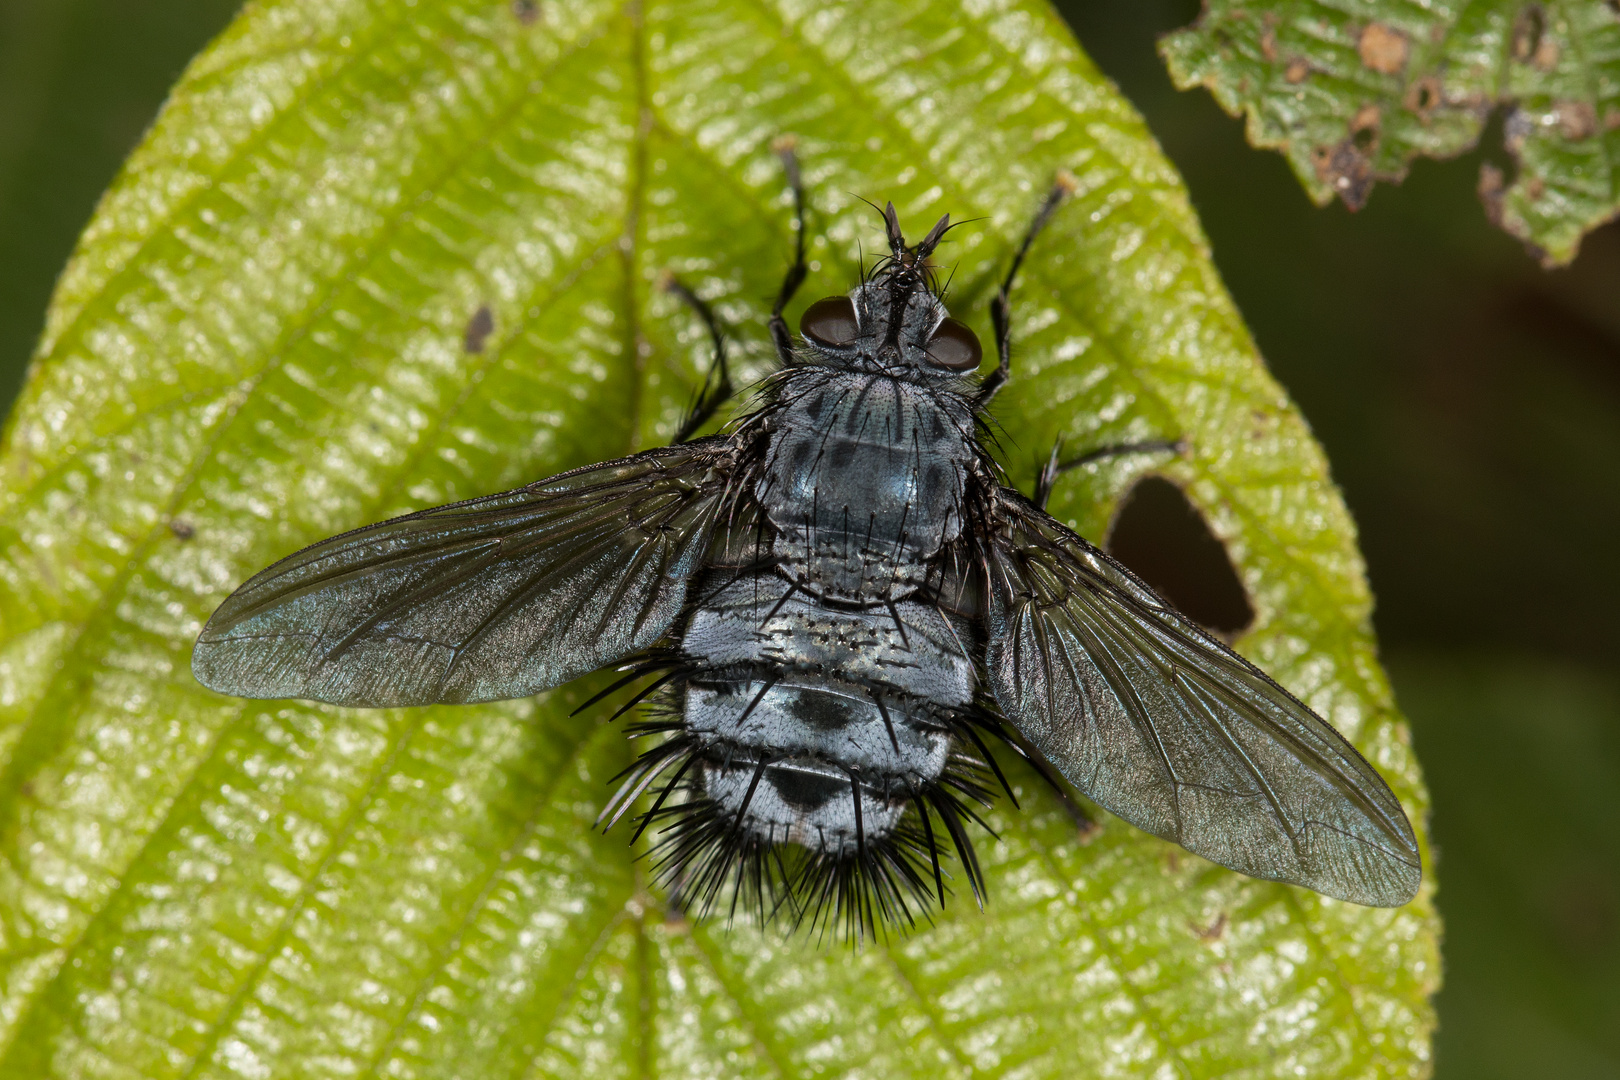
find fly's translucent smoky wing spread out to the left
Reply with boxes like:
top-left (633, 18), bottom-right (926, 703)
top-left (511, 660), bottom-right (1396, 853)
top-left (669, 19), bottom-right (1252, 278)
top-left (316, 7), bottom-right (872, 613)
top-left (191, 439), bottom-right (731, 706)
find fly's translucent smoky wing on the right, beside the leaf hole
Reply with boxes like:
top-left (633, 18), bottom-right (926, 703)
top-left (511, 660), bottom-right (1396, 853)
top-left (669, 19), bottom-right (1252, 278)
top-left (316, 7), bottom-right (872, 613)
top-left (985, 491), bottom-right (1421, 907)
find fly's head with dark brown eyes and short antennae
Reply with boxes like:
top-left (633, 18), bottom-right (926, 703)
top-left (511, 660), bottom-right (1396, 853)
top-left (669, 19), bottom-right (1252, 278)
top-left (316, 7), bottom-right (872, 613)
top-left (799, 202), bottom-right (983, 379)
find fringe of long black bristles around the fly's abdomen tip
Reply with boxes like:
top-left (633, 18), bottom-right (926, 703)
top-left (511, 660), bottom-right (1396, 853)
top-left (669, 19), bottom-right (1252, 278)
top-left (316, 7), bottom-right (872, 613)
top-left (593, 637), bottom-right (1024, 944)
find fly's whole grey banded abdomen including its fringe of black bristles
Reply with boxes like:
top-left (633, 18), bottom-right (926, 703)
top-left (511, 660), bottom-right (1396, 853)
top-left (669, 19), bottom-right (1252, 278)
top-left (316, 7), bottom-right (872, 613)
top-left (616, 568), bottom-right (983, 933)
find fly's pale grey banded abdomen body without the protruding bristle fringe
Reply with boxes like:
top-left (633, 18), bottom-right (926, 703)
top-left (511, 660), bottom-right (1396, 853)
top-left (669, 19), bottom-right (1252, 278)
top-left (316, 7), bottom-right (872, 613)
top-left (680, 573), bottom-right (974, 852)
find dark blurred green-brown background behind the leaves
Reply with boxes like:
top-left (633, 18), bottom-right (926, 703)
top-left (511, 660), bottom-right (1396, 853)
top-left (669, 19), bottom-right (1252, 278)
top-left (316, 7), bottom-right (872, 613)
top-left (0, 0), bottom-right (1620, 1080)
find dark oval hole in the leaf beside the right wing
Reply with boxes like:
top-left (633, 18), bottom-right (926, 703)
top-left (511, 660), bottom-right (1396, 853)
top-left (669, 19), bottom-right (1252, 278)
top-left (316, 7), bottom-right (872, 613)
top-left (1106, 476), bottom-right (1254, 641)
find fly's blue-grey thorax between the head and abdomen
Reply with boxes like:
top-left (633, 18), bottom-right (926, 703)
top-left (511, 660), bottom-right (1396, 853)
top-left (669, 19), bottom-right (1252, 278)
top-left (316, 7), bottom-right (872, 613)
top-left (755, 371), bottom-right (975, 599)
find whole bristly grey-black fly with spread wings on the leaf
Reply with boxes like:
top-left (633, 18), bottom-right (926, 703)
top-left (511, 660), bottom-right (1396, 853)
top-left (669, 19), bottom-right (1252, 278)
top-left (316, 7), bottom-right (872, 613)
top-left (191, 152), bottom-right (1421, 936)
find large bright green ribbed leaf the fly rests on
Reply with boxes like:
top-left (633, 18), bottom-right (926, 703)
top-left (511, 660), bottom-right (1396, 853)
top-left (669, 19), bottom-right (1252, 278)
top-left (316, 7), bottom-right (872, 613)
top-left (0, 0), bottom-right (1439, 1077)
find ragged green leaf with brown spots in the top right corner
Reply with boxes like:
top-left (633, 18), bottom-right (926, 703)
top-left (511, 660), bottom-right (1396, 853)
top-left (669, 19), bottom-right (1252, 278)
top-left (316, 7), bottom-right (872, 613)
top-left (1160, 0), bottom-right (1620, 266)
